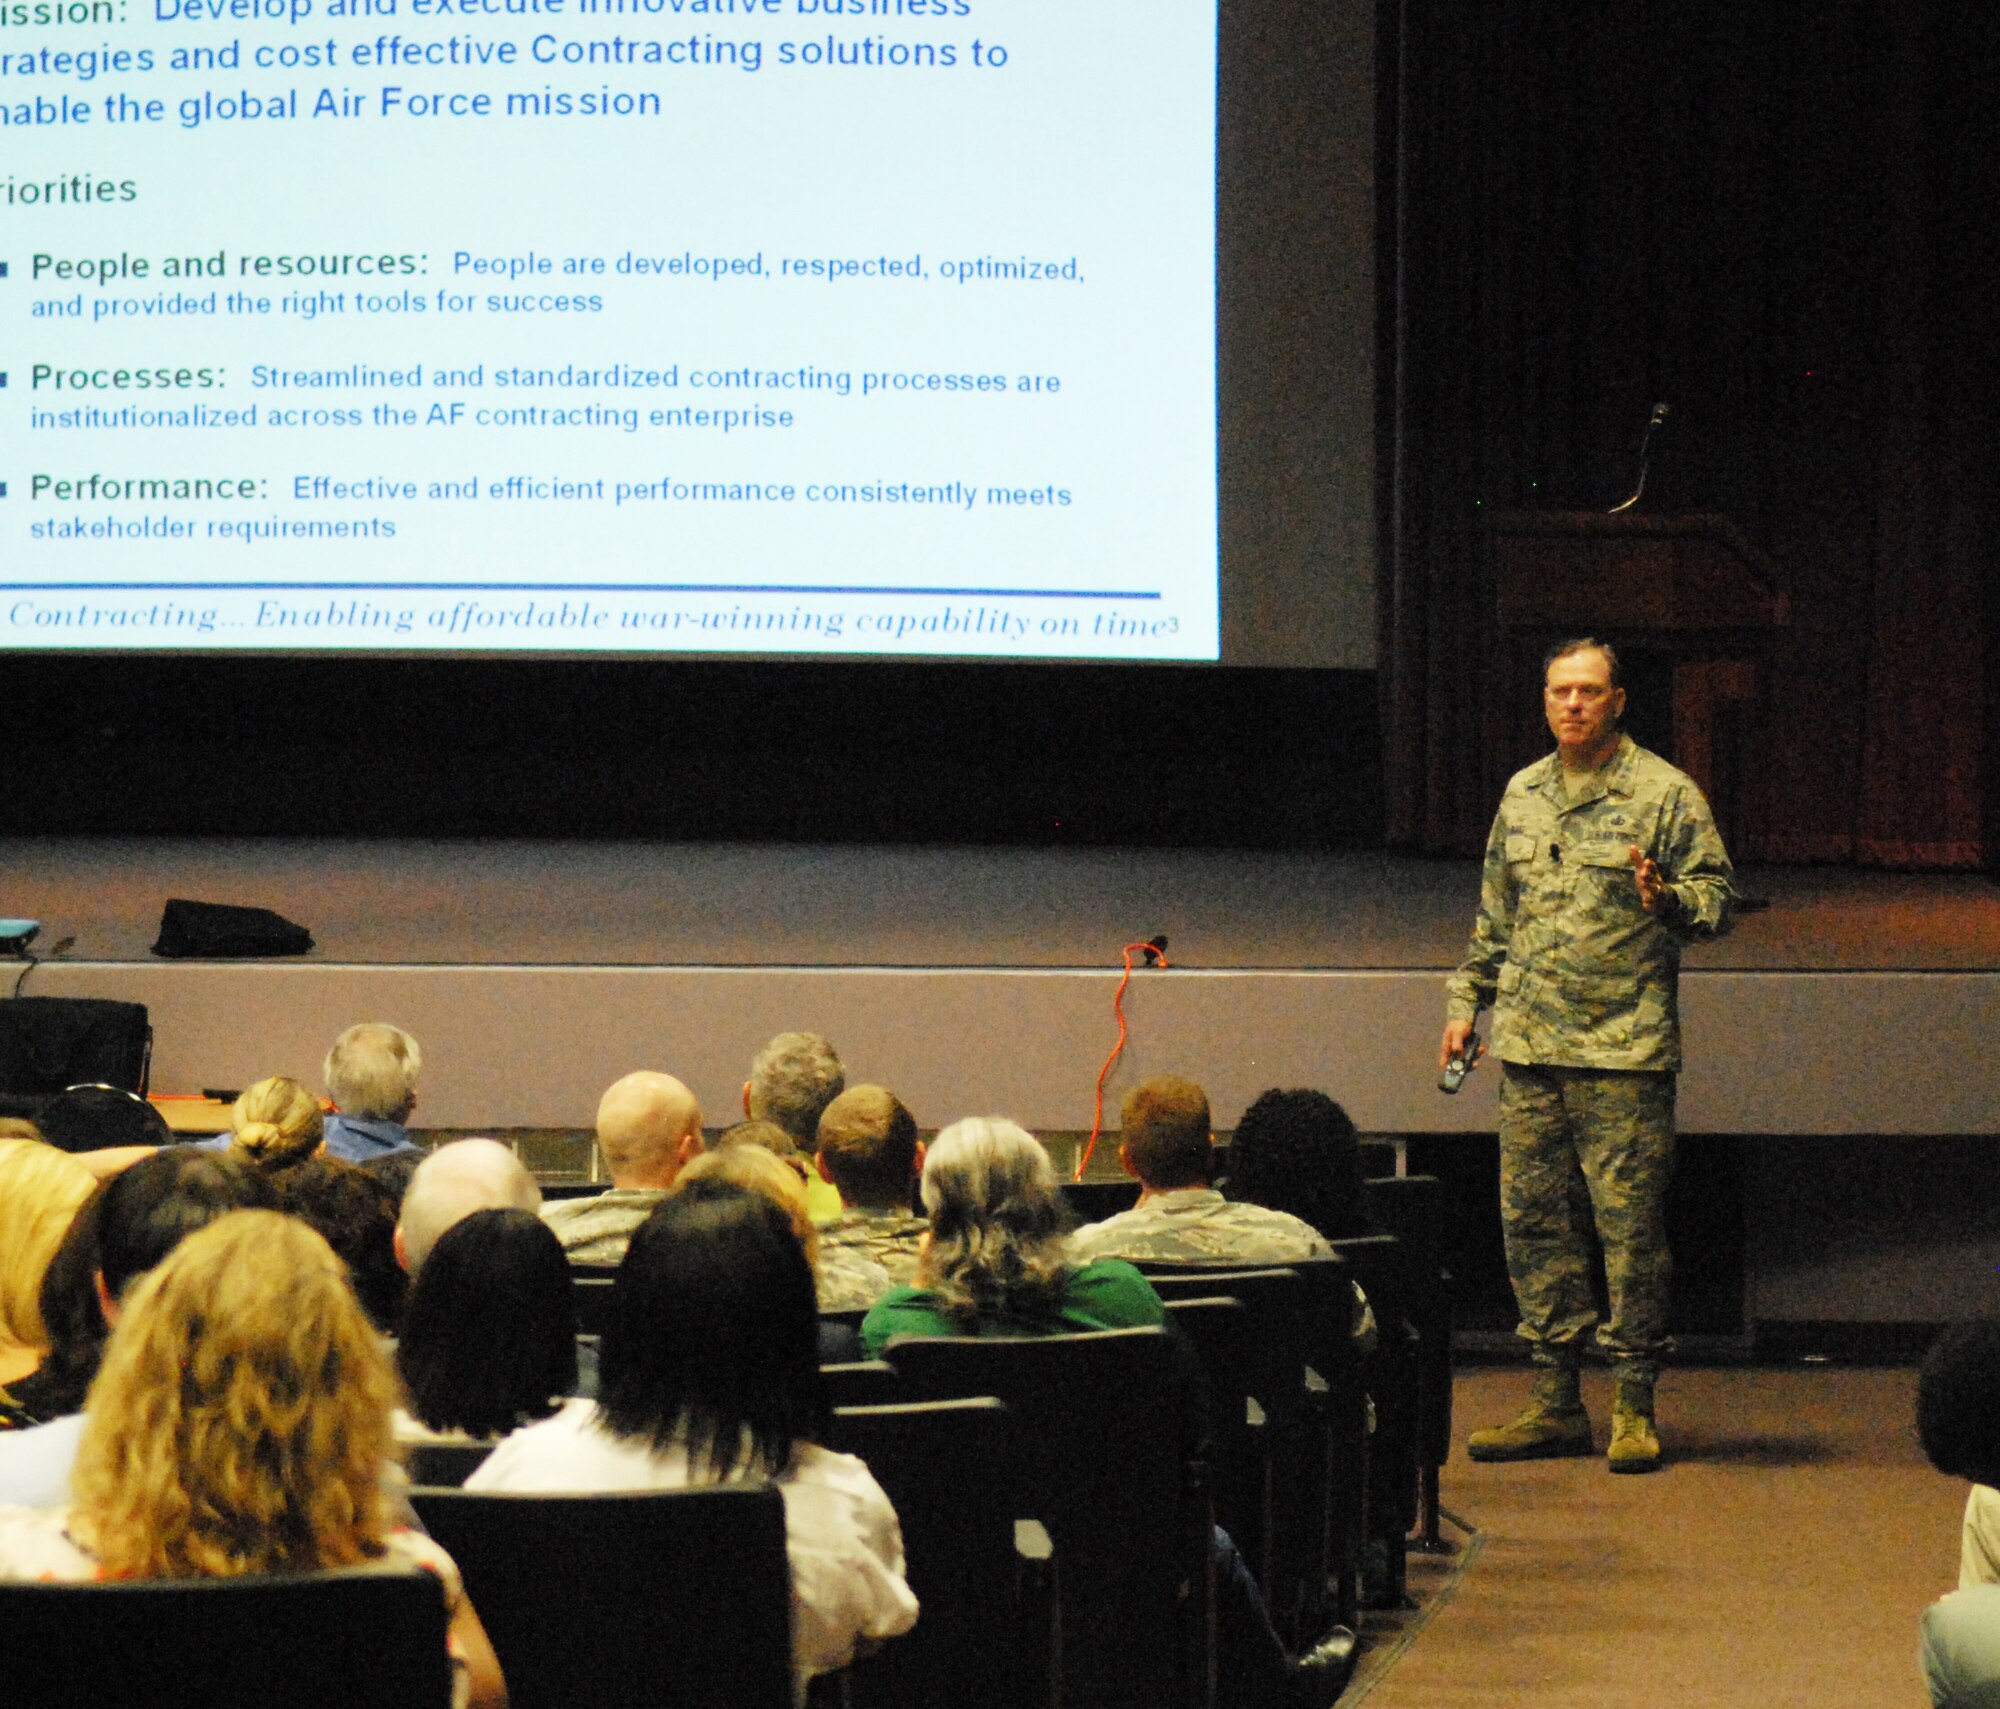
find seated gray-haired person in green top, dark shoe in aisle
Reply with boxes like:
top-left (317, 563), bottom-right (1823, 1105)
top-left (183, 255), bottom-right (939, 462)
top-left (862, 1117), bottom-right (1354, 1709)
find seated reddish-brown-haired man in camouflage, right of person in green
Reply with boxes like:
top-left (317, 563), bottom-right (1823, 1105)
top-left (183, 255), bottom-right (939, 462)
top-left (1070, 1075), bottom-right (1334, 1265)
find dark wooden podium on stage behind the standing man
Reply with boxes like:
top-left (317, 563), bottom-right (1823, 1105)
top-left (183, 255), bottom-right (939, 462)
top-left (1490, 510), bottom-right (1792, 852)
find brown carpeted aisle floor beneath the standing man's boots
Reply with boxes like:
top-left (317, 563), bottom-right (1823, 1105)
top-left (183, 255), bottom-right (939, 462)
top-left (1342, 1367), bottom-right (1964, 1709)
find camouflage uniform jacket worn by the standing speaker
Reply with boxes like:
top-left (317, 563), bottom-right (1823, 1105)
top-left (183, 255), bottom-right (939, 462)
top-left (1446, 736), bottom-right (1734, 1073)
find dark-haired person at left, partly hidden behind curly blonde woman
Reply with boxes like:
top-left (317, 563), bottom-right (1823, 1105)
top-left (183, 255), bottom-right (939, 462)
top-left (0, 1145), bottom-right (274, 1456)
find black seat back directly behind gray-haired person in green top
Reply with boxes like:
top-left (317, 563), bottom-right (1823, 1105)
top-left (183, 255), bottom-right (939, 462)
top-left (884, 1329), bottom-right (1216, 1709)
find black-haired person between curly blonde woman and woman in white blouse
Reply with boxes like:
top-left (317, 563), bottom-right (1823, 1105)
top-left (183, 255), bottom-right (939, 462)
top-left (396, 1211), bottom-right (576, 1441)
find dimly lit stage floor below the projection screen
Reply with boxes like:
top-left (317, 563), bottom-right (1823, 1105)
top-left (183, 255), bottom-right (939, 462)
top-left (0, 838), bottom-right (2000, 973)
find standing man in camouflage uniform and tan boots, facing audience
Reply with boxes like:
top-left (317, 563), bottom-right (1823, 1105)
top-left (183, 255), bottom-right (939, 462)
top-left (1438, 640), bottom-right (1732, 1471)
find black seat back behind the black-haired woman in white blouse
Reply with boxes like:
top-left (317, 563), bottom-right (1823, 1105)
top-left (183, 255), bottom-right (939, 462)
top-left (410, 1485), bottom-right (792, 1709)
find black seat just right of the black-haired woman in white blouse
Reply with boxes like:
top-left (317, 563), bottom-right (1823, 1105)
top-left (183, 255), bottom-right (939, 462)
top-left (826, 1397), bottom-right (1062, 1709)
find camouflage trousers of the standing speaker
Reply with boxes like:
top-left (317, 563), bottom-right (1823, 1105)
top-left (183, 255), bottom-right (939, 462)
top-left (1500, 1063), bottom-right (1674, 1377)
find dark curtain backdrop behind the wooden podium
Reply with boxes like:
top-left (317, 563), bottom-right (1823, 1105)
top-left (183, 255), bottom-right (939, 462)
top-left (1380, 0), bottom-right (2000, 867)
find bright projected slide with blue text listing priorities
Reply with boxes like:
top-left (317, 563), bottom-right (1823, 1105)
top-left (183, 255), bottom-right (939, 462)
top-left (0, 0), bottom-right (1218, 658)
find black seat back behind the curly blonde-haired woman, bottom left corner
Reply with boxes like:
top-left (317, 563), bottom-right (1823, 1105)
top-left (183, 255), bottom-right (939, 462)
top-left (0, 1571), bottom-right (452, 1709)
